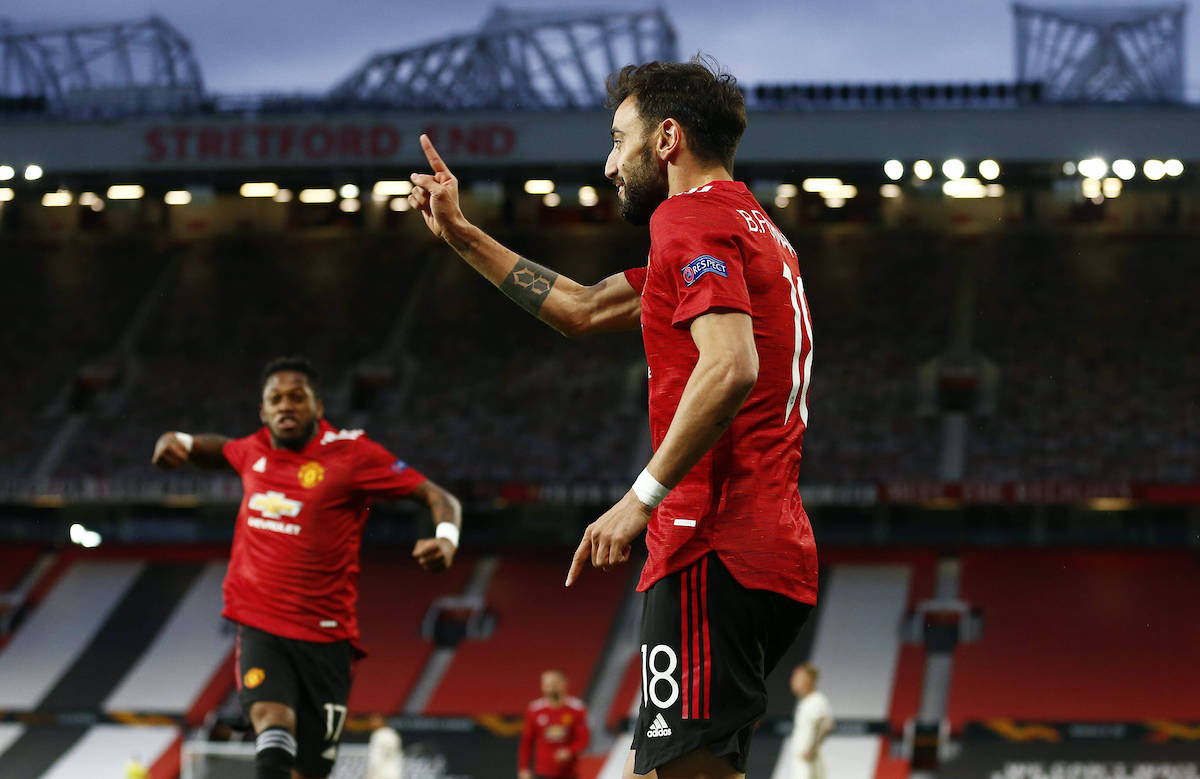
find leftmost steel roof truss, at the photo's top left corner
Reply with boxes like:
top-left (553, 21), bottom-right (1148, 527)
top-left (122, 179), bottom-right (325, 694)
top-left (0, 16), bottom-right (204, 116)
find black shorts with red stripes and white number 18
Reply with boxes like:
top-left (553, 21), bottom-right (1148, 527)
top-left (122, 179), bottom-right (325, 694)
top-left (632, 552), bottom-right (812, 774)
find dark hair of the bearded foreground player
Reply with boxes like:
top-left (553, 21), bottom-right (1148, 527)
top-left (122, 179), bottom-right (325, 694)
top-left (607, 54), bottom-right (746, 173)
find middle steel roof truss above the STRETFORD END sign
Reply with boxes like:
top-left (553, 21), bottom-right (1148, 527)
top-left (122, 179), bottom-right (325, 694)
top-left (331, 7), bottom-right (678, 109)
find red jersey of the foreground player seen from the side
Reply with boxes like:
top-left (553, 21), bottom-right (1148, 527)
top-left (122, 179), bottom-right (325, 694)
top-left (625, 181), bottom-right (817, 604)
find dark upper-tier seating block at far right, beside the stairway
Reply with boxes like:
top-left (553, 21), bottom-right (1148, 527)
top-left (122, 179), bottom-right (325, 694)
top-left (968, 232), bottom-right (1200, 483)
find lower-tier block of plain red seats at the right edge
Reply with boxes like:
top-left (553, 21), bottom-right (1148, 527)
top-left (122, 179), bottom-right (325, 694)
top-left (949, 550), bottom-right (1200, 729)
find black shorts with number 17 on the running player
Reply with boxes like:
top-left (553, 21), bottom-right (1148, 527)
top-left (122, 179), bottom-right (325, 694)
top-left (236, 625), bottom-right (354, 777)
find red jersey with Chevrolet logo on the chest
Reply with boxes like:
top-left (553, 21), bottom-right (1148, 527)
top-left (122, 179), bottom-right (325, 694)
top-left (223, 420), bottom-right (425, 646)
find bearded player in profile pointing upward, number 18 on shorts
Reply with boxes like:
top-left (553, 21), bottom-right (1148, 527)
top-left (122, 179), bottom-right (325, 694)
top-left (409, 59), bottom-right (817, 779)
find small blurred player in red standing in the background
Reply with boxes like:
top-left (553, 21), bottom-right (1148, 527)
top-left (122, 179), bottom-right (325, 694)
top-left (517, 670), bottom-right (592, 779)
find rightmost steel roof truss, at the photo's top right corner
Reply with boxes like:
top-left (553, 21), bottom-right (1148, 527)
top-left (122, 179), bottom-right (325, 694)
top-left (1013, 4), bottom-right (1187, 103)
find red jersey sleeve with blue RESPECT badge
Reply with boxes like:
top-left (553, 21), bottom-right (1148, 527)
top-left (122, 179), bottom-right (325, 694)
top-left (652, 198), bottom-right (752, 329)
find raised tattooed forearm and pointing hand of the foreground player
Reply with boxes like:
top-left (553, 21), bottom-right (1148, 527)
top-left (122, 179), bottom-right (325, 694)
top-left (408, 134), bottom-right (642, 336)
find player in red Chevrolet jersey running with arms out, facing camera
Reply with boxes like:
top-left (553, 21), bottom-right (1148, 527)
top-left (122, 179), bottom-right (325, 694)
top-left (152, 358), bottom-right (462, 779)
